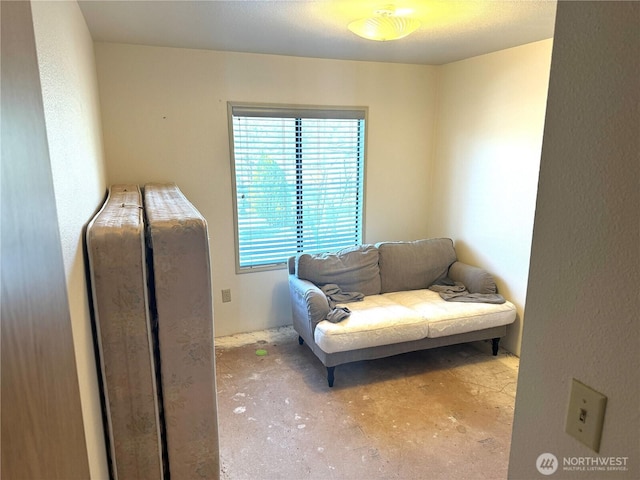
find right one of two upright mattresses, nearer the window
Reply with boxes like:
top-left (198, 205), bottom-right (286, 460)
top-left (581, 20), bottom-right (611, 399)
top-left (144, 184), bottom-right (220, 480)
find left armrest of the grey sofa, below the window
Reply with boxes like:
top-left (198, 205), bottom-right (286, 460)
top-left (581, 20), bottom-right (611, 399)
top-left (289, 275), bottom-right (331, 341)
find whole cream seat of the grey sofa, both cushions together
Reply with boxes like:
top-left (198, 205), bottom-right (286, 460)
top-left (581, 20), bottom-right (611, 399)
top-left (314, 289), bottom-right (516, 353)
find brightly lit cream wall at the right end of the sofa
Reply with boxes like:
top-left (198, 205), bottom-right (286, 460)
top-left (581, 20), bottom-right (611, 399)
top-left (428, 40), bottom-right (552, 355)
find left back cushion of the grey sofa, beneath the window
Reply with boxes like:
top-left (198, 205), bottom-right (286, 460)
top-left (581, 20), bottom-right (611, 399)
top-left (296, 245), bottom-right (380, 295)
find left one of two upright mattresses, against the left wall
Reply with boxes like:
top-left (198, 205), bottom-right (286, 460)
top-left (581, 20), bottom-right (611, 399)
top-left (87, 185), bottom-right (163, 480)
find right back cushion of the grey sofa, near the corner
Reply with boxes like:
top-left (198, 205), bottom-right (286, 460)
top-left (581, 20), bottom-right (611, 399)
top-left (376, 238), bottom-right (456, 293)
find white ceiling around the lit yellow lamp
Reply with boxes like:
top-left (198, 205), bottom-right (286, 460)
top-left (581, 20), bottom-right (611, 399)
top-left (78, 0), bottom-right (556, 65)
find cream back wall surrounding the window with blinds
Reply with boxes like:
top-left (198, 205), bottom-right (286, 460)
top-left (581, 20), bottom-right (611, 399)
top-left (96, 43), bottom-right (437, 336)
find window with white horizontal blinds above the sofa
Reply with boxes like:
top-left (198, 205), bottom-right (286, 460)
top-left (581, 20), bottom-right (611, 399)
top-left (229, 103), bottom-right (366, 272)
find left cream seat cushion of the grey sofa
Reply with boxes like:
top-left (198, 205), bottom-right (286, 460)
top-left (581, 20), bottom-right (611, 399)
top-left (314, 295), bottom-right (428, 353)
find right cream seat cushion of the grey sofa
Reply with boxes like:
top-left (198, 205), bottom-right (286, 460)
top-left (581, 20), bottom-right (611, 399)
top-left (382, 289), bottom-right (516, 338)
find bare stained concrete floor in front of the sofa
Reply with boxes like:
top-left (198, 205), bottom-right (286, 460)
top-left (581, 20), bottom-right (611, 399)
top-left (216, 328), bottom-right (518, 480)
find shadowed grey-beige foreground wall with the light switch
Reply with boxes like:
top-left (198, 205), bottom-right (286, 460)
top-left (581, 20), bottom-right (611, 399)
top-left (509, 2), bottom-right (640, 479)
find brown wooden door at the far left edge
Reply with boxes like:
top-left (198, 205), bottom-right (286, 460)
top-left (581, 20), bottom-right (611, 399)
top-left (0, 1), bottom-right (89, 480)
